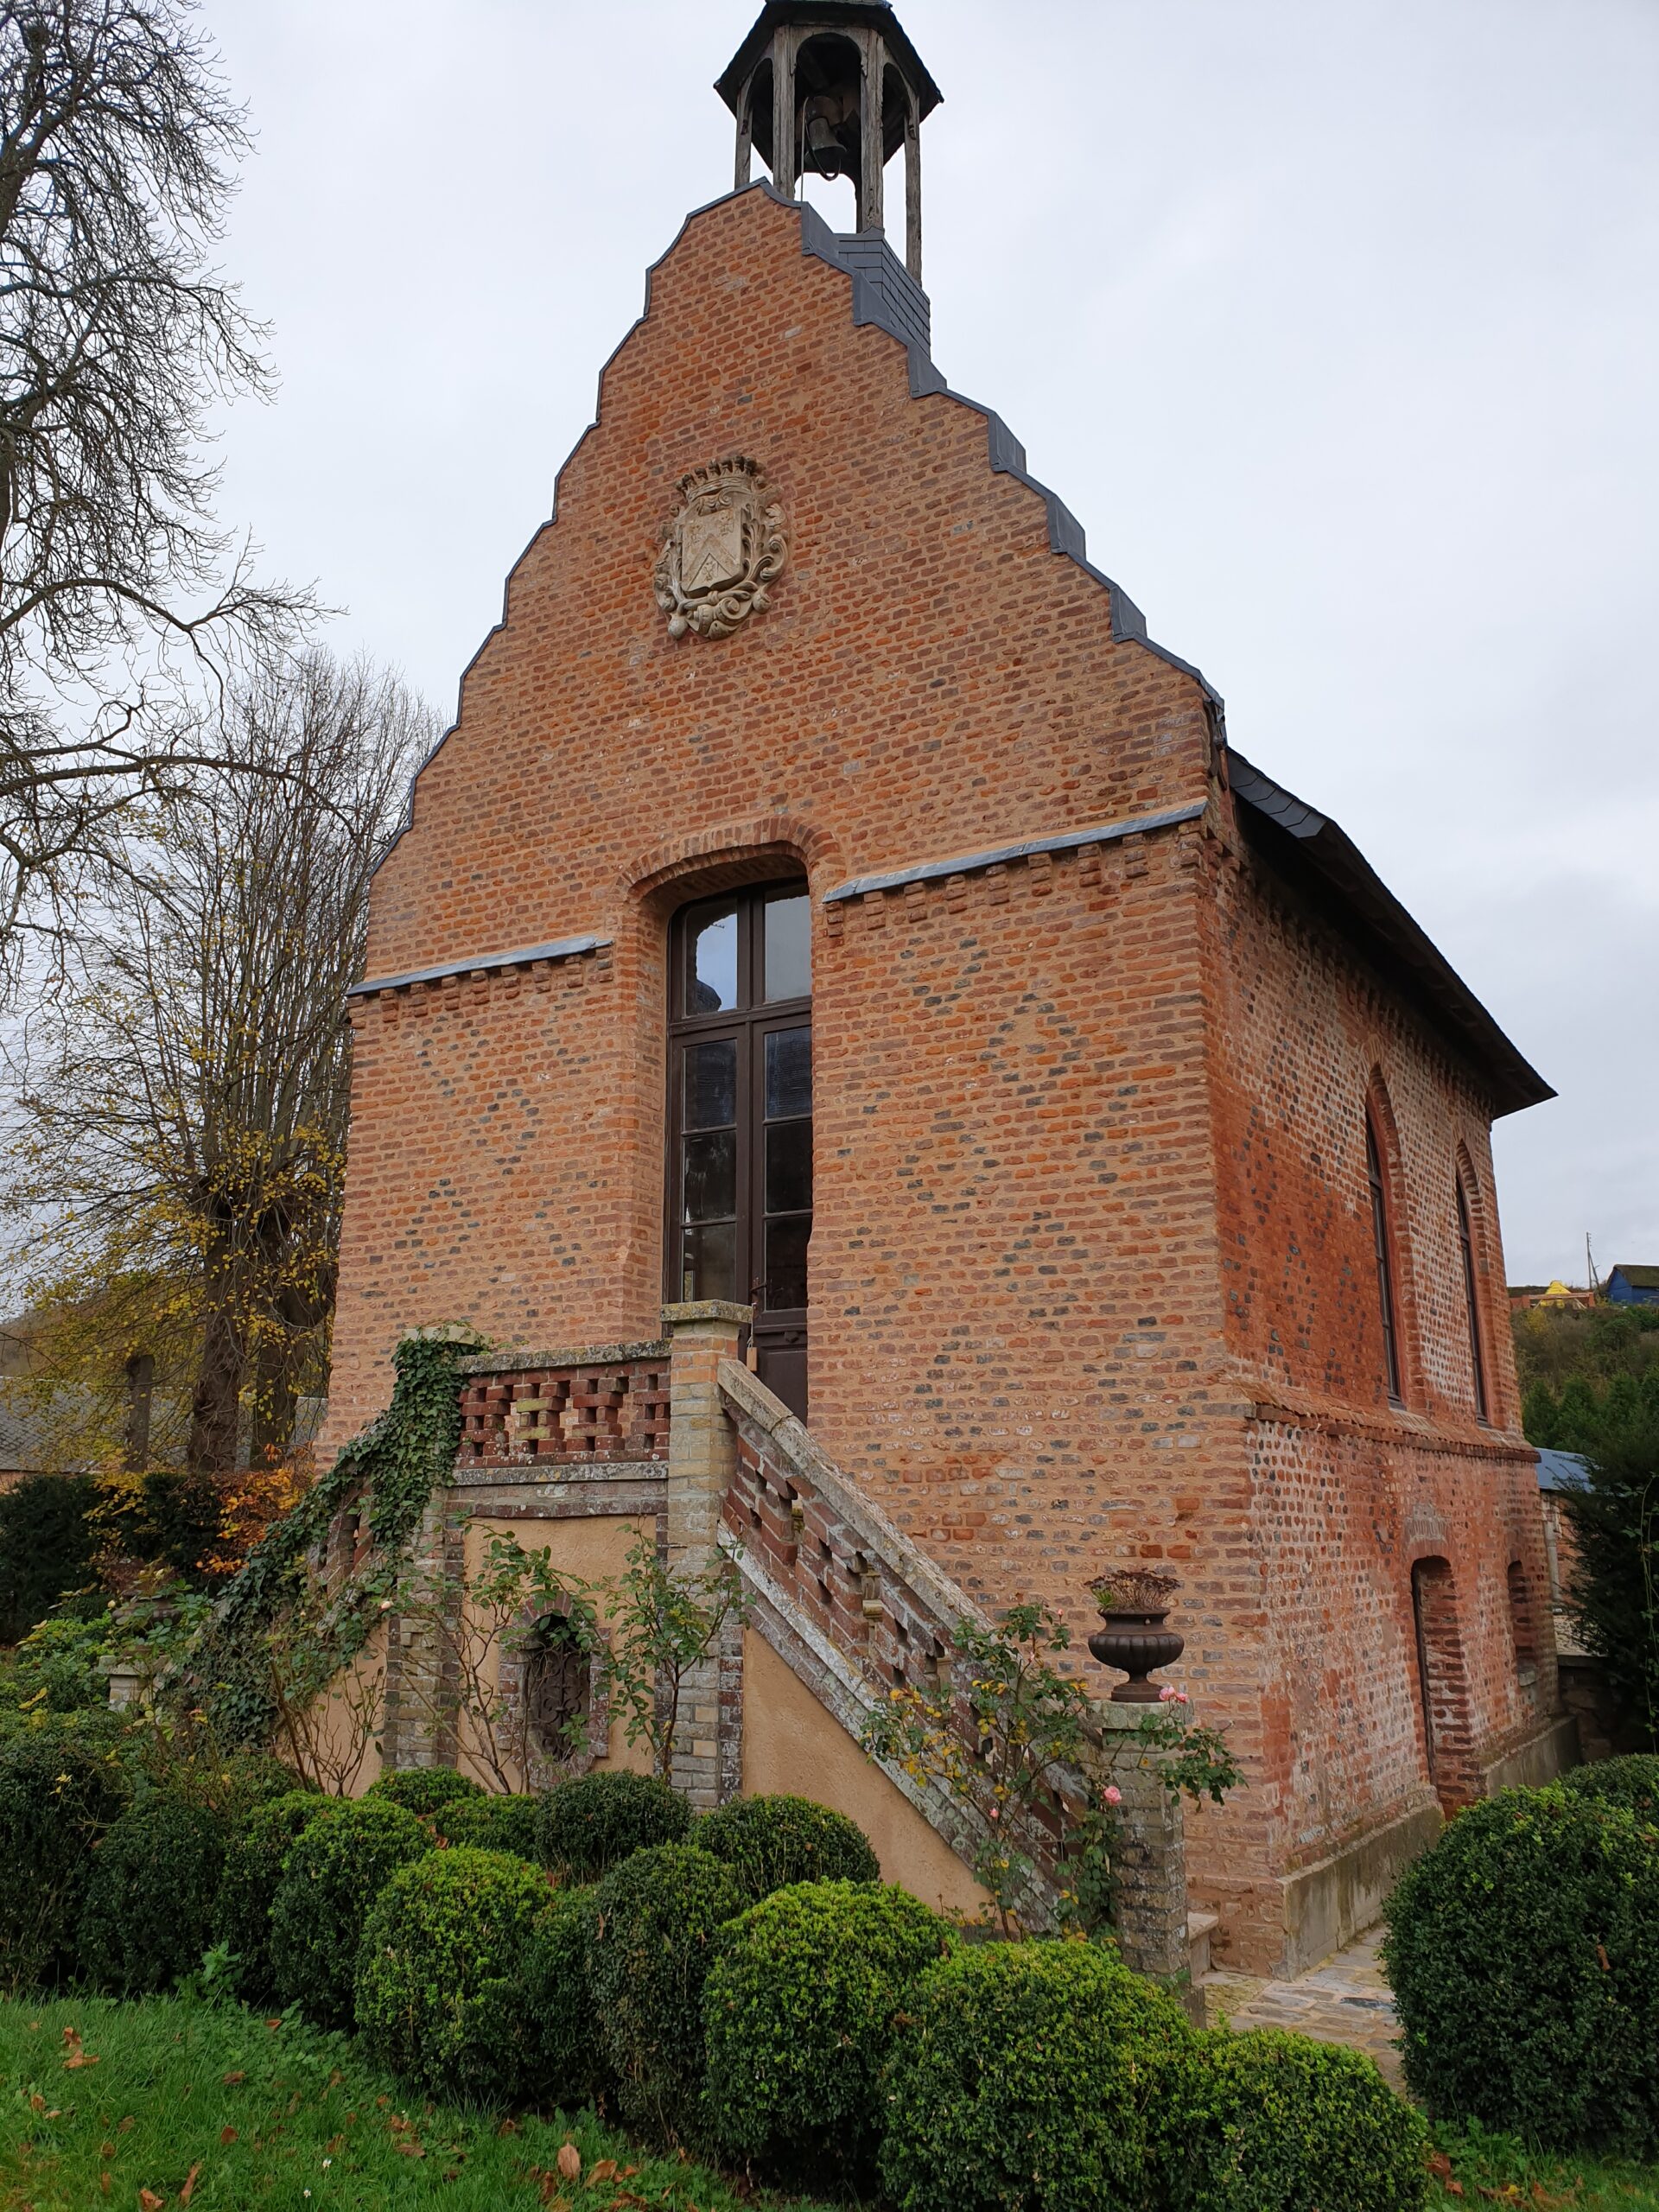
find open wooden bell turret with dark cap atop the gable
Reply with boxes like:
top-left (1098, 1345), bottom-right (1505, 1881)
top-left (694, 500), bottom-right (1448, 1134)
top-left (715, 0), bottom-right (943, 283)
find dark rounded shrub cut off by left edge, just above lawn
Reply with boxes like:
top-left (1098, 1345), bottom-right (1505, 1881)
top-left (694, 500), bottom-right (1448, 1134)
top-left (0, 1727), bottom-right (126, 1991)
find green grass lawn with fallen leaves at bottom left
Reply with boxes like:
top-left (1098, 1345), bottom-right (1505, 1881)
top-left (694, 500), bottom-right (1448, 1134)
top-left (0, 1998), bottom-right (836, 2212)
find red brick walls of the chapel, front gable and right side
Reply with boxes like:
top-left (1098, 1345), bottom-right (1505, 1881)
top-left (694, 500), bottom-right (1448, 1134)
top-left (329, 193), bottom-right (1541, 1942)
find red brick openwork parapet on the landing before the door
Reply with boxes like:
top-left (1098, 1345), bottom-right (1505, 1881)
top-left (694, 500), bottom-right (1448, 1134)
top-left (455, 1344), bottom-right (671, 1471)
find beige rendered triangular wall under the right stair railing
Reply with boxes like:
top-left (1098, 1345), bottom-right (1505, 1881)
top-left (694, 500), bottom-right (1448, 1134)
top-left (743, 1628), bottom-right (991, 1916)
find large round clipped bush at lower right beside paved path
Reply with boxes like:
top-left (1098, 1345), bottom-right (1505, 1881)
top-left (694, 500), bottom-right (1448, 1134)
top-left (1382, 1787), bottom-right (1659, 2157)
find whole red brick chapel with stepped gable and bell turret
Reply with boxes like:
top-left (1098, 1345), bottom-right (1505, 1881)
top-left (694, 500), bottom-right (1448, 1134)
top-left (329, 0), bottom-right (1571, 1971)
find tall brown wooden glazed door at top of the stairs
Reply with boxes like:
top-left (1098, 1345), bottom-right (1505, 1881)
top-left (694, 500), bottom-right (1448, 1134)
top-left (668, 882), bottom-right (812, 1421)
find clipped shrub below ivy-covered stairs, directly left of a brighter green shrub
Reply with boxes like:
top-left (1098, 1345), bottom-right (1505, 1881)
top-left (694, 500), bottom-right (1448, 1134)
top-left (270, 1794), bottom-right (431, 2029)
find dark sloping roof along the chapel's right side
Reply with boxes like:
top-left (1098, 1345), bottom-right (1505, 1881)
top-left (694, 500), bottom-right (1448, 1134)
top-left (1228, 747), bottom-right (1555, 1115)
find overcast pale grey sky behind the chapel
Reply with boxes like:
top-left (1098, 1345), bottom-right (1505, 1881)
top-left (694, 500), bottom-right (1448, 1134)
top-left (204, 0), bottom-right (1659, 1281)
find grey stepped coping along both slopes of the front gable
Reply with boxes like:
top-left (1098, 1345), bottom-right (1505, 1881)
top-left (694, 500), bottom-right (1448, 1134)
top-left (374, 177), bottom-right (1228, 876)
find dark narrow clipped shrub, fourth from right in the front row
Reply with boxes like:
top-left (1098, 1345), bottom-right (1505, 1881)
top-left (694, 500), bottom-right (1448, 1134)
top-left (588, 1842), bottom-right (746, 2141)
